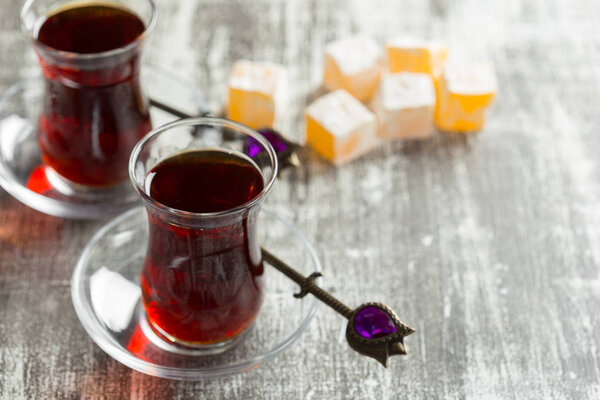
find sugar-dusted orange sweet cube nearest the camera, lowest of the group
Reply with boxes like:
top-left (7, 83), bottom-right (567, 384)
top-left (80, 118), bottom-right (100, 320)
top-left (305, 89), bottom-right (378, 165)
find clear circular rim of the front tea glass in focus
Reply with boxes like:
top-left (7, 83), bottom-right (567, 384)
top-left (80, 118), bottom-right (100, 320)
top-left (129, 117), bottom-right (278, 219)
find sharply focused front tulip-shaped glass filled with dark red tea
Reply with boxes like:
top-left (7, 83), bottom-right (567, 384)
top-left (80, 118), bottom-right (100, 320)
top-left (129, 118), bottom-right (277, 353)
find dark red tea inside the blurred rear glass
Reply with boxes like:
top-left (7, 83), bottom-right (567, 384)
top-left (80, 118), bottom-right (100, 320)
top-left (35, 3), bottom-right (152, 186)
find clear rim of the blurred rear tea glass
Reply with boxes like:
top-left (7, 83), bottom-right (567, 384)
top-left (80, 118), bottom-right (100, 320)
top-left (20, 0), bottom-right (158, 60)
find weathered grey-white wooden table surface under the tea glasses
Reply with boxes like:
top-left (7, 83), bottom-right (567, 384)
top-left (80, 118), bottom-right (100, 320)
top-left (0, 0), bottom-right (600, 399)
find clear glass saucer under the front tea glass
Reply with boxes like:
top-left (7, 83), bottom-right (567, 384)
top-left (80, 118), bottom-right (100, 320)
top-left (71, 208), bottom-right (321, 380)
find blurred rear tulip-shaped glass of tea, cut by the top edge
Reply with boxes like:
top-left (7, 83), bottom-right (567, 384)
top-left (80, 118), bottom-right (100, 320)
top-left (21, 0), bottom-right (156, 192)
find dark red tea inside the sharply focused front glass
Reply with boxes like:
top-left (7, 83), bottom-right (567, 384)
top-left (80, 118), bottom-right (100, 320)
top-left (141, 150), bottom-right (264, 344)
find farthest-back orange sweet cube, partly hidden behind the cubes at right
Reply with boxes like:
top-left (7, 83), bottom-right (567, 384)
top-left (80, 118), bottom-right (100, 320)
top-left (385, 38), bottom-right (448, 79)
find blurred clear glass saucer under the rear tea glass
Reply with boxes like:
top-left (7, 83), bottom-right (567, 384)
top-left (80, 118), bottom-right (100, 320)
top-left (0, 66), bottom-right (207, 219)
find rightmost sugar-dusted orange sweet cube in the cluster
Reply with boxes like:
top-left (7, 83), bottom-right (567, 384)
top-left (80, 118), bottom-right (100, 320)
top-left (435, 62), bottom-right (497, 132)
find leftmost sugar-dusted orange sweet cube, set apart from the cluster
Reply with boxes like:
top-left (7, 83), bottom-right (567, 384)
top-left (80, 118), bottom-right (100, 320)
top-left (227, 60), bottom-right (287, 129)
